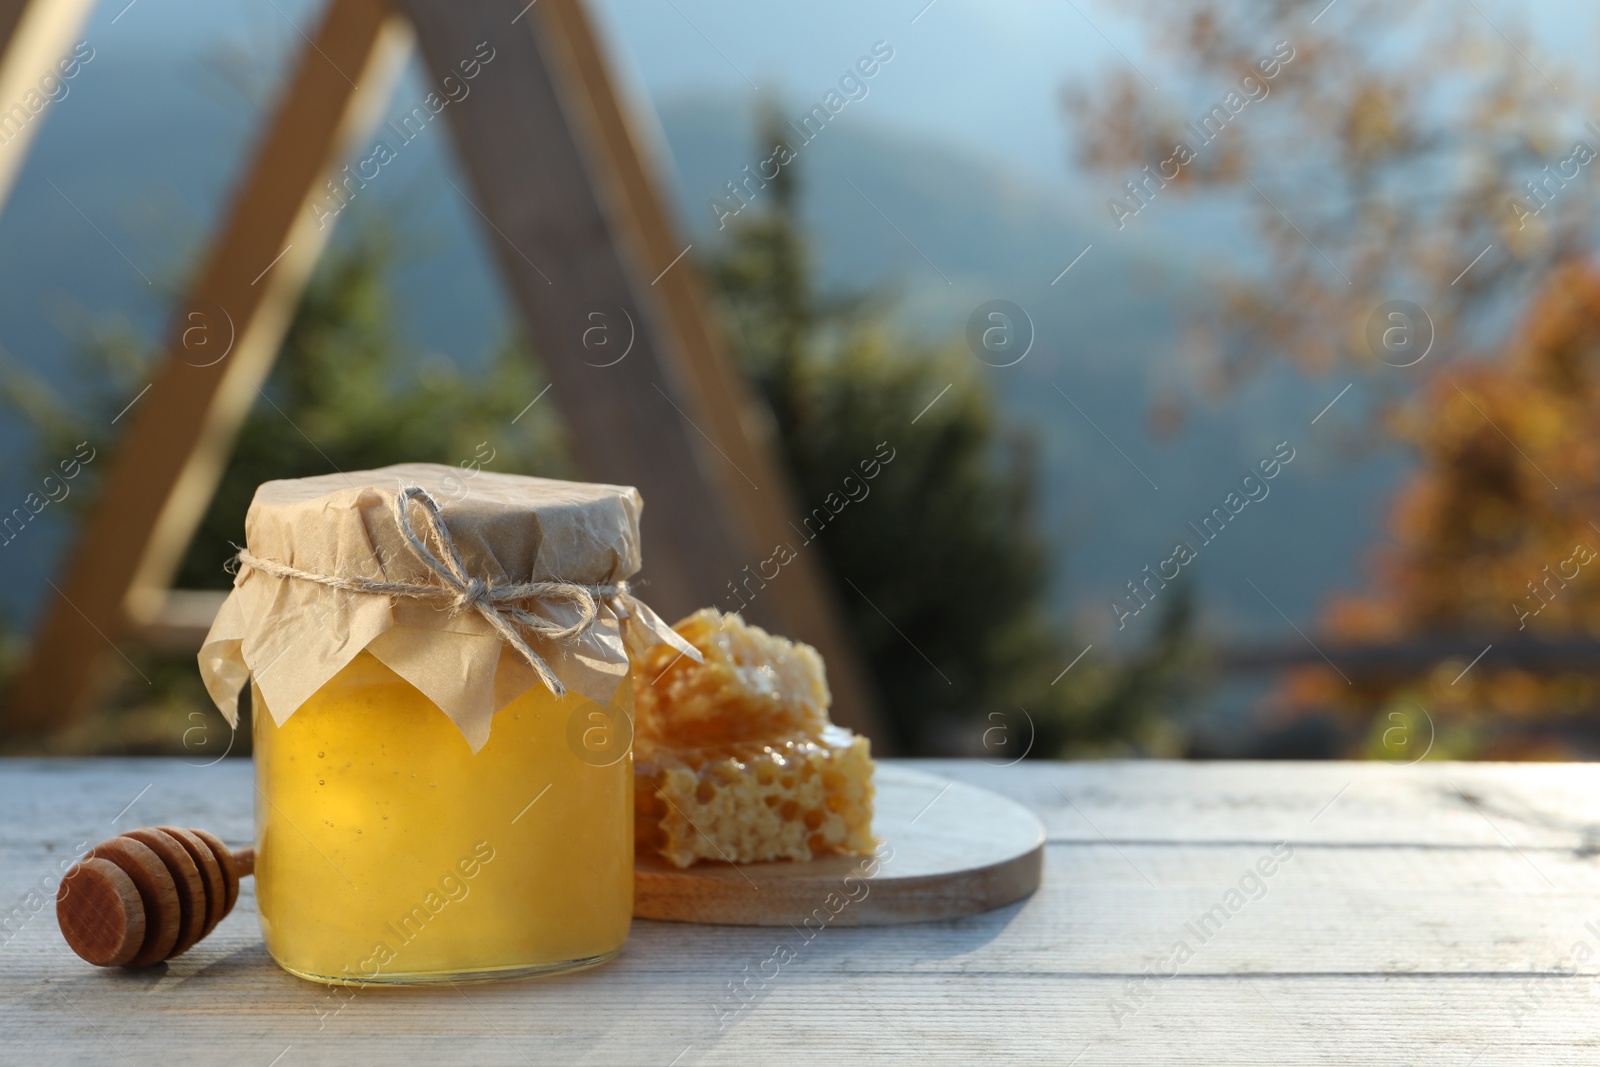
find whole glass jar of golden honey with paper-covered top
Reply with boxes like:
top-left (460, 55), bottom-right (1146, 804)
top-left (202, 464), bottom-right (694, 984)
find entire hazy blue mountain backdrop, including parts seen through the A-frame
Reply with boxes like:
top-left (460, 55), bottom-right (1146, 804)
top-left (0, 58), bottom-right (1400, 654)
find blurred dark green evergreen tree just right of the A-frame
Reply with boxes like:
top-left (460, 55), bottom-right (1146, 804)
top-left (710, 103), bottom-right (1187, 758)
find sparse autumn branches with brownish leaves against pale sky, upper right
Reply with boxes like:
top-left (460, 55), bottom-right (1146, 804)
top-left (1064, 0), bottom-right (1600, 395)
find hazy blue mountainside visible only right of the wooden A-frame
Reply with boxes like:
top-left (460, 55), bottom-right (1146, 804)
top-left (643, 99), bottom-right (1402, 653)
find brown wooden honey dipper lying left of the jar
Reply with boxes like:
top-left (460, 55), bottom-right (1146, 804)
top-left (56, 825), bottom-right (256, 966)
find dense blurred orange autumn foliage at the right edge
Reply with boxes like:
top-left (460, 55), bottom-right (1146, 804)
top-left (1282, 262), bottom-right (1600, 758)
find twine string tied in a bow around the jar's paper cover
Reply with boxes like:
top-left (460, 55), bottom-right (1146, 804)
top-left (235, 485), bottom-right (627, 696)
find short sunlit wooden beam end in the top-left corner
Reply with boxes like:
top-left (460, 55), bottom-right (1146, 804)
top-left (0, 0), bottom-right (93, 206)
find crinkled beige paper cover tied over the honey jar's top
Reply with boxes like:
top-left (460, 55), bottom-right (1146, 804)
top-left (200, 464), bottom-right (699, 750)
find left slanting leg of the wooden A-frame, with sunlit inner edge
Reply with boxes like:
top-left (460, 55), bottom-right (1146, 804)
top-left (5, 0), bottom-right (408, 734)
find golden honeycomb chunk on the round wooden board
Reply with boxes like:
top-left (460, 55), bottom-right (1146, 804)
top-left (634, 609), bottom-right (877, 867)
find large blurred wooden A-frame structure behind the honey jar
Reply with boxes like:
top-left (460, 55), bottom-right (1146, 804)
top-left (0, 0), bottom-right (890, 750)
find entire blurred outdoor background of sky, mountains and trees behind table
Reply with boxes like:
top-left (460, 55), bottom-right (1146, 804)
top-left (0, 0), bottom-right (1600, 761)
